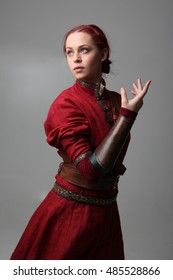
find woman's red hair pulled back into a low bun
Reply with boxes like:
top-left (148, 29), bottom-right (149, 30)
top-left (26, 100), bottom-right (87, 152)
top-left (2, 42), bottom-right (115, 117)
top-left (63, 24), bottom-right (111, 73)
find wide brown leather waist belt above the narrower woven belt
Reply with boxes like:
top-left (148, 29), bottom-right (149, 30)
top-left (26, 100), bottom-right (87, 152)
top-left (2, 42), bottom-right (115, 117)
top-left (58, 162), bottom-right (120, 191)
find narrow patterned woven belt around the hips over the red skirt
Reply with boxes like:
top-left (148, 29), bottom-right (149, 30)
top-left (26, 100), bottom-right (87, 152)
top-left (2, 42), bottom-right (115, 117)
top-left (52, 183), bottom-right (118, 206)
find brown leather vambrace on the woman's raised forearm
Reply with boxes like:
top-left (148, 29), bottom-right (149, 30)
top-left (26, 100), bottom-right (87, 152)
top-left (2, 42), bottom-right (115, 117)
top-left (90, 115), bottom-right (135, 175)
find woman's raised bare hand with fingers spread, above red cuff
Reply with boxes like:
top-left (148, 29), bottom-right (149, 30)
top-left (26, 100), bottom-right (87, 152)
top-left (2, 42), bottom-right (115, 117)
top-left (121, 79), bottom-right (151, 112)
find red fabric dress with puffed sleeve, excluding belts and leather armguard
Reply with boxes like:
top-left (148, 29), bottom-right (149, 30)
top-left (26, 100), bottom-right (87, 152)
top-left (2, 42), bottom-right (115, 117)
top-left (11, 81), bottom-right (129, 260)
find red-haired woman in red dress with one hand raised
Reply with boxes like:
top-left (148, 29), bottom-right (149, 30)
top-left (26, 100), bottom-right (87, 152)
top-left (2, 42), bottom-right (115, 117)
top-left (11, 25), bottom-right (151, 260)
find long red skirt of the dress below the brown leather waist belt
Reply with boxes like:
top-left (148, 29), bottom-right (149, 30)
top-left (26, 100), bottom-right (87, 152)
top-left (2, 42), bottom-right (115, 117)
top-left (11, 178), bottom-right (124, 260)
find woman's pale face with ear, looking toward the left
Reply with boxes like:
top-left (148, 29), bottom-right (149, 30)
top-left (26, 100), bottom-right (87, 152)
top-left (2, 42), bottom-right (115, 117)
top-left (65, 32), bottom-right (107, 83)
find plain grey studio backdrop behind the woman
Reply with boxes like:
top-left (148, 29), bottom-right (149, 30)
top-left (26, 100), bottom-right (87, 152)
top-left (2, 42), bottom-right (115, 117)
top-left (0, 0), bottom-right (173, 259)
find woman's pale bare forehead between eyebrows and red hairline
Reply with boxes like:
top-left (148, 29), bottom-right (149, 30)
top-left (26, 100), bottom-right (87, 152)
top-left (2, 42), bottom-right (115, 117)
top-left (65, 31), bottom-right (94, 48)
